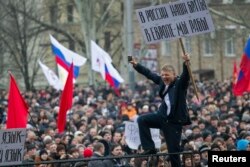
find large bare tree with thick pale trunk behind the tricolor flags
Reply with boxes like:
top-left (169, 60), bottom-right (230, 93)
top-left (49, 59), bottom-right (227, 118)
top-left (0, 0), bottom-right (122, 85)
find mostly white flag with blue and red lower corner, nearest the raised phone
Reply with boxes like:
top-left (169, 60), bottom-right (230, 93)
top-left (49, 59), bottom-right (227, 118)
top-left (91, 41), bottom-right (124, 94)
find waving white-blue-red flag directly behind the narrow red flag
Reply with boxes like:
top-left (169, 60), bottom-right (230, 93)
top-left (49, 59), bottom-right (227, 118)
top-left (50, 35), bottom-right (86, 88)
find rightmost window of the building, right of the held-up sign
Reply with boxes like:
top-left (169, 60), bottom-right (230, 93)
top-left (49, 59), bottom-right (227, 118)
top-left (224, 29), bottom-right (235, 57)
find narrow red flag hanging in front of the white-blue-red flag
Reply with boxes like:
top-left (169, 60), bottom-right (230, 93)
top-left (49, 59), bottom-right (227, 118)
top-left (57, 63), bottom-right (73, 133)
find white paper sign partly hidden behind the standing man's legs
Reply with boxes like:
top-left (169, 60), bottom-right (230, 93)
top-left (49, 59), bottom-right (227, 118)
top-left (125, 122), bottom-right (161, 150)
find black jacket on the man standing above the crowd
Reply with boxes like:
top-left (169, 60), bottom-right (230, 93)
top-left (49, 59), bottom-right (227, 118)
top-left (134, 63), bottom-right (191, 125)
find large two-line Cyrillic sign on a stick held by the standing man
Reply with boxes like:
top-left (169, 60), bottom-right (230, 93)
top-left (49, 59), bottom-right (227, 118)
top-left (136, 0), bottom-right (214, 43)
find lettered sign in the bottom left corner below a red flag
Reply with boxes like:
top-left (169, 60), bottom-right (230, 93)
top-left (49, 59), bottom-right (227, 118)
top-left (0, 128), bottom-right (26, 166)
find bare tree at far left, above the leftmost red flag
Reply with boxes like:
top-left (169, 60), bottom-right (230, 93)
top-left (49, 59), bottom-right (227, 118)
top-left (0, 0), bottom-right (48, 90)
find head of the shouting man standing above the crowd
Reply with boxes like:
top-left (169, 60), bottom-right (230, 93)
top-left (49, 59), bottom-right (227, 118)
top-left (161, 65), bottom-right (175, 85)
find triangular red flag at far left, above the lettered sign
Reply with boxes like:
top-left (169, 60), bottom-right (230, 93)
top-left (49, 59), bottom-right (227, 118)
top-left (6, 74), bottom-right (28, 129)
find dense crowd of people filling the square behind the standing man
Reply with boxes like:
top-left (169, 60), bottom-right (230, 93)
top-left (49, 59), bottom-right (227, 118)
top-left (0, 76), bottom-right (250, 167)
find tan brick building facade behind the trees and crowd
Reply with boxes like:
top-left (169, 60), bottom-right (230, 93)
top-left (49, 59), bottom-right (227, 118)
top-left (36, 0), bottom-right (250, 88)
